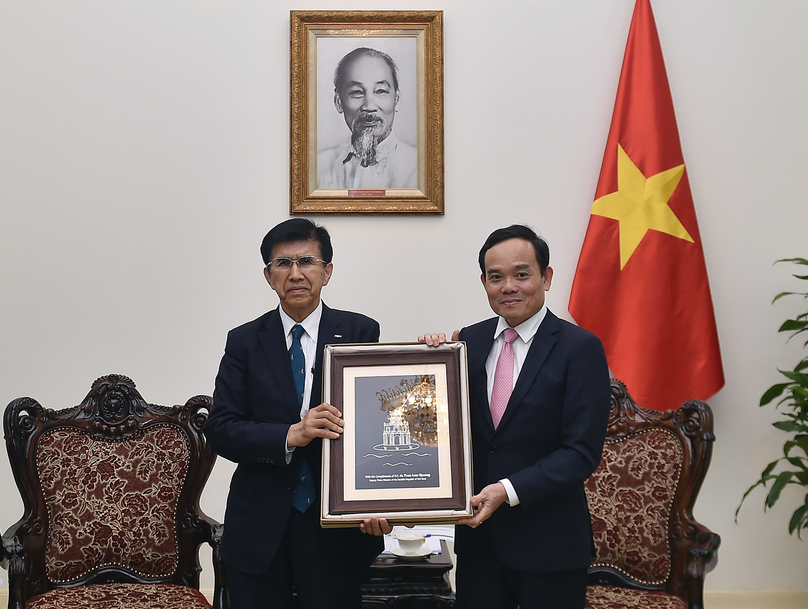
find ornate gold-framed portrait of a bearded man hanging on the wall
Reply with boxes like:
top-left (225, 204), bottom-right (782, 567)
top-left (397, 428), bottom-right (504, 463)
top-left (289, 11), bottom-right (444, 214)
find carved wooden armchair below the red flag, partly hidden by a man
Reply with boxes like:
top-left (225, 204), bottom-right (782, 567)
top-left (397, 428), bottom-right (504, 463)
top-left (586, 379), bottom-right (721, 609)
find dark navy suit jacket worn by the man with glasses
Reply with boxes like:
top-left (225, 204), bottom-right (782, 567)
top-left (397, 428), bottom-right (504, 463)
top-left (205, 304), bottom-right (383, 574)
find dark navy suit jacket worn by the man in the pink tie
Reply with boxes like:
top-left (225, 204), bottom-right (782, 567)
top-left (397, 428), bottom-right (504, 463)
top-left (455, 311), bottom-right (610, 572)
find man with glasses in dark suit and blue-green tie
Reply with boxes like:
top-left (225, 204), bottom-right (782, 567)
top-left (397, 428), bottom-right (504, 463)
top-left (205, 218), bottom-right (392, 609)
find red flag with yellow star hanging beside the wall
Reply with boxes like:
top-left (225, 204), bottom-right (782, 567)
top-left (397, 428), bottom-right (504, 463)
top-left (569, 0), bottom-right (724, 410)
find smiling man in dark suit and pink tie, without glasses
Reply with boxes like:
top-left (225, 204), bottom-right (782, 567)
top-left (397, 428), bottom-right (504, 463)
top-left (419, 225), bottom-right (610, 609)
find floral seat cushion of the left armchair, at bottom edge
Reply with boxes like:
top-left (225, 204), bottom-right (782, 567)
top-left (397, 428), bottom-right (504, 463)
top-left (26, 584), bottom-right (210, 609)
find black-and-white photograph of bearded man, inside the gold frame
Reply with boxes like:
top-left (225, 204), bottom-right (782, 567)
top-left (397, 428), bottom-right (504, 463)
top-left (316, 36), bottom-right (418, 190)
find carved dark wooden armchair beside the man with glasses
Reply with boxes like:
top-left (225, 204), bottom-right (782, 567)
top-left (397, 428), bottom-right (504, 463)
top-left (2, 374), bottom-right (227, 609)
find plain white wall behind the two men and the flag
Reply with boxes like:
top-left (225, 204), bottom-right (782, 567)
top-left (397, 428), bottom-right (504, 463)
top-left (0, 0), bottom-right (808, 591)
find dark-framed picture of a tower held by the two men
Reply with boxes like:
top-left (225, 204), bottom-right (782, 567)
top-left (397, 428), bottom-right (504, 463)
top-left (320, 342), bottom-right (473, 527)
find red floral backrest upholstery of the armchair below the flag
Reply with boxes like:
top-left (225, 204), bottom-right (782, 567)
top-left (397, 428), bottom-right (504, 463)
top-left (586, 428), bottom-right (682, 584)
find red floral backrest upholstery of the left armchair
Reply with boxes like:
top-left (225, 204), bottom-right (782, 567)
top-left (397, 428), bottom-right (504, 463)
top-left (36, 425), bottom-right (189, 583)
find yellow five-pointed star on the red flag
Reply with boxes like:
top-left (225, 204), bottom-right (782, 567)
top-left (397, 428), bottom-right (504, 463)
top-left (592, 144), bottom-right (693, 270)
